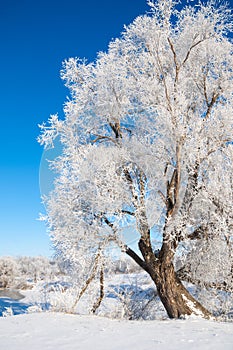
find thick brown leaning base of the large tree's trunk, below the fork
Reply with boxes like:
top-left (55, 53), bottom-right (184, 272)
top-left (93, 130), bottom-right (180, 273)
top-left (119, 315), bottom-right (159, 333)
top-left (150, 262), bottom-right (211, 318)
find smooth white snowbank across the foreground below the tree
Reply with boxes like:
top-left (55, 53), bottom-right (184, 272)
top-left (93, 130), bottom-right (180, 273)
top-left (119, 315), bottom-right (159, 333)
top-left (0, 312), bottom-right (233, 350)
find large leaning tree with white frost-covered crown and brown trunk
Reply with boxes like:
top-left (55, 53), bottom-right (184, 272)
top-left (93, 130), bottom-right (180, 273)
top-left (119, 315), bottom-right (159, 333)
top-left (40, 0), bottom-right (233, 318)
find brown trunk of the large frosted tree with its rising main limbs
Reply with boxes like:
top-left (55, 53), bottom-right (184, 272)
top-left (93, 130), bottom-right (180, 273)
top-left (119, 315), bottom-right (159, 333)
top-left (125, 160), bottom-right (211, 318)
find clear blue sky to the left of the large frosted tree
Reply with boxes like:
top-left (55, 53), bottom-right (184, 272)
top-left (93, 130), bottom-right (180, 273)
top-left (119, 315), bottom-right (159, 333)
top-left (0, 0), bottom-right (149, 256)
